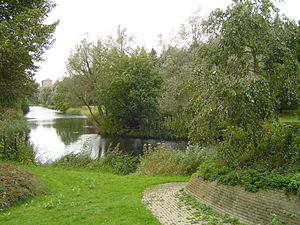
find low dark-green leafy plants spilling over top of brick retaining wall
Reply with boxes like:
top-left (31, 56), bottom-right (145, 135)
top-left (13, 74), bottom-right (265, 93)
top-left (197, 160), bottom-right (300, 195)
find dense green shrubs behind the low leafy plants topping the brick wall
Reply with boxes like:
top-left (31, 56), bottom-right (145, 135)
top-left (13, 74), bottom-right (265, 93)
top-left (216, 124), bottom-right (300, 170)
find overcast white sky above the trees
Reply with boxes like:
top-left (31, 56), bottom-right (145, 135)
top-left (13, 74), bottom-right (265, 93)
top-left (35, 0), bottom-right (300, 83)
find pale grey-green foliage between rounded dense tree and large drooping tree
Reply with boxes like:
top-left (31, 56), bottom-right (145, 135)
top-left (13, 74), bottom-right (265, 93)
top-left (157, 45), bottom-right (197, 138)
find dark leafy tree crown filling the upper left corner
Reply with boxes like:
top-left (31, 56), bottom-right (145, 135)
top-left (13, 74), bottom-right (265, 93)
top-left (0, 0), bottom-right (57, 107)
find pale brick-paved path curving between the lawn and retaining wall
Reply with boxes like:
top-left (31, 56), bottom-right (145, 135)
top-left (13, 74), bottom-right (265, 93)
top-left (142, 183), bottom-right (199, 225)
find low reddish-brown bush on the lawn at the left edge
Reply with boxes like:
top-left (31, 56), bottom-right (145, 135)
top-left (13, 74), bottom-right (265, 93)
top-left (0, 164), bottom-right (46, 209)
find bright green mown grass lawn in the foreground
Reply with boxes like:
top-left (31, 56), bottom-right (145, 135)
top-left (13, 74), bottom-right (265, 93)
top-left (0, 161), bottom-right (189, 225)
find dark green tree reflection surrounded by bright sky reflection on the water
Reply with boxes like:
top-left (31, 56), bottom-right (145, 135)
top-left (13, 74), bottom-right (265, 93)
top-left (53, 118), bottom-right (84, 145)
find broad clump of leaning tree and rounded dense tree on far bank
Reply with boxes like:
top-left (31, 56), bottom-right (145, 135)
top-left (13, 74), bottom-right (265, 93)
top-left (67, 28), bottom-right (161, 134)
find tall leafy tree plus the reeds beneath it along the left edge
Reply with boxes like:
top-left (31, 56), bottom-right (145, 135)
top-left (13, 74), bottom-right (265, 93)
top-left (0, 0), bottom-right (57, 161)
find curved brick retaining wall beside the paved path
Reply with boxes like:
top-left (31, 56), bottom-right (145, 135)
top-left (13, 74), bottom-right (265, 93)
top-left (185, 177), bottom-right (300, 225)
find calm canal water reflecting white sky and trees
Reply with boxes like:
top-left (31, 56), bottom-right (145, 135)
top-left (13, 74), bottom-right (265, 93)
top-left (25, 106), bottom-right (187, 163)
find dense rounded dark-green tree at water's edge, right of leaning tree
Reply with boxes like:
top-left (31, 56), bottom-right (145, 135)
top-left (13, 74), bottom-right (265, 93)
top-left (97, 49), bottom-right (162, 133)
